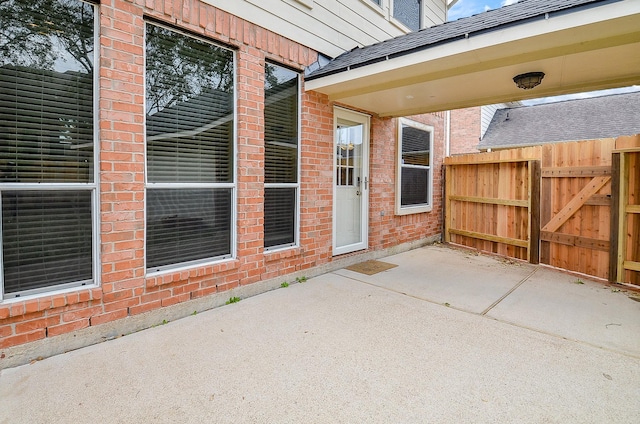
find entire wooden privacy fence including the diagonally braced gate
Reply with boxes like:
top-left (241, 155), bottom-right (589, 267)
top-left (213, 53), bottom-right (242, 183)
top-left (444, 136), bottom-right (640, 284)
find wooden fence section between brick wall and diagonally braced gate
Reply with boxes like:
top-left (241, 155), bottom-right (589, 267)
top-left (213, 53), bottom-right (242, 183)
top-left (445, 158), bottom-right (540, 263)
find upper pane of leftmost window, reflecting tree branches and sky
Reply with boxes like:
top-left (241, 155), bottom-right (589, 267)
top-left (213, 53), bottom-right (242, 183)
top-left (0, 0), bottom-right (94, 183)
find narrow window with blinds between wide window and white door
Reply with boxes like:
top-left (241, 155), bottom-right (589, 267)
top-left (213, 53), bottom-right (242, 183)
top-left (264, 63), bottom-right (300, 249)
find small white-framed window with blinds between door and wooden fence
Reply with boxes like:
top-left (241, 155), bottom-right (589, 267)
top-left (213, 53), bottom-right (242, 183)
top-left (396, 118), bottom-right (433, 214)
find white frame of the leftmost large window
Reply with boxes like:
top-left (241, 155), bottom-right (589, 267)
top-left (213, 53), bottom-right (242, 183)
top-left (0, 0), bottom-right (101, 303)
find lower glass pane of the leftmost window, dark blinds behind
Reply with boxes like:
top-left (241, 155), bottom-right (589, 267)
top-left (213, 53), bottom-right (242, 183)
top-left (2, 191), bottom-right (93, 294)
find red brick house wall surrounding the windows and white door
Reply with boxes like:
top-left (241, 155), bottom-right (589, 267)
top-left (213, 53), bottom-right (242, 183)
top-left (0, 0), bottom-right (443, 352)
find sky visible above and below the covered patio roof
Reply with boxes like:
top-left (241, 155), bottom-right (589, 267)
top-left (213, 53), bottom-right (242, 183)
top-left (449, 0), bottom-right (640, 105)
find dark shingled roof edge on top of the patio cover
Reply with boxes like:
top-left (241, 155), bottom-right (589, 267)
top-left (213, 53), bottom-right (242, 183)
top-left (305, 0), bottom-right (620, 80)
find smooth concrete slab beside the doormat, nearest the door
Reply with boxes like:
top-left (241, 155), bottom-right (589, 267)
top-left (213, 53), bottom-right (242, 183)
top-left (336, 245), bottom-right (537, 314)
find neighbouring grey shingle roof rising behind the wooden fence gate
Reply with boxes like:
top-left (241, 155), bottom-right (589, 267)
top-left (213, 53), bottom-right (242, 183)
top-left (478, 91), bottom-right (640, 150)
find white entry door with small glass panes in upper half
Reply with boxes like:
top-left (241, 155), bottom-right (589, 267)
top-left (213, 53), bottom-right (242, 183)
top-left (333, 108), bottom-right (369, 255)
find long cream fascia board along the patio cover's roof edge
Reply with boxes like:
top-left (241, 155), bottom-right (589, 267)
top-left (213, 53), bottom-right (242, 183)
top-left (305, 0), bottom-right (640, 93)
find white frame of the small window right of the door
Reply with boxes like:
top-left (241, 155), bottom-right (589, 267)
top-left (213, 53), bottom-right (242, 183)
top-left (395, 118), bottom-right (434, 215)
